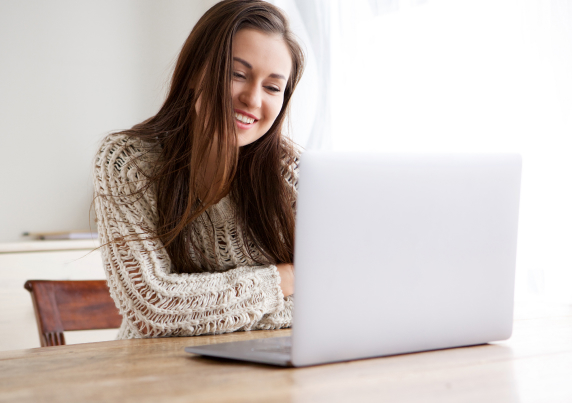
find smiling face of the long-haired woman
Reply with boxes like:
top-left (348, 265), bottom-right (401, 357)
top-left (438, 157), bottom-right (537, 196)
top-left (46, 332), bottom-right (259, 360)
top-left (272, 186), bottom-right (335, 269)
top-left (232, 29), bottom-right (292, 147)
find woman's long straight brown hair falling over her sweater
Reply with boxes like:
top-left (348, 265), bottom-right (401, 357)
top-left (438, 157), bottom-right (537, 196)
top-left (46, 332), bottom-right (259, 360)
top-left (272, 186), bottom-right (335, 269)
top-left (118, 0), bottom-right (304, 273)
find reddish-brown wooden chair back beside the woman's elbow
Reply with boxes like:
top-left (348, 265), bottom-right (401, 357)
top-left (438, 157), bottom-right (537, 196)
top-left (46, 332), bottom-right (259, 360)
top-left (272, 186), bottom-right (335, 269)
top-left (24, 280), bottom-right (122, 347)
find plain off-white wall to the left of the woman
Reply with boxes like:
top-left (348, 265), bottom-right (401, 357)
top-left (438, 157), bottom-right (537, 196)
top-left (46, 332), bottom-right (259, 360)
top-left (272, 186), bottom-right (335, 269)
top-left (0, 0), bottom-right (216, 242)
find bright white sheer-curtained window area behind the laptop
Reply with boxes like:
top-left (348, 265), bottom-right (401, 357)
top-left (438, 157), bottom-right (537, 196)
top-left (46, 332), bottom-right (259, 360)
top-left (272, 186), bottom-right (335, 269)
top-left (290, 0), bottom-right (572, 303)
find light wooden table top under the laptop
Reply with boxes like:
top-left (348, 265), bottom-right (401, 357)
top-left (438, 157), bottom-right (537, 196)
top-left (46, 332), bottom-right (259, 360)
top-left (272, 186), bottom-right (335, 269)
top-left (0, 305), bottom-right (572, 403)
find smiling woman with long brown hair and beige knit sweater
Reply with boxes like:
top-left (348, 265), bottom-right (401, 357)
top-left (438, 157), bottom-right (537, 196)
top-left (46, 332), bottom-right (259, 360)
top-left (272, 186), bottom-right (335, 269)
top-left (94, 0), bottom-right (303, 338)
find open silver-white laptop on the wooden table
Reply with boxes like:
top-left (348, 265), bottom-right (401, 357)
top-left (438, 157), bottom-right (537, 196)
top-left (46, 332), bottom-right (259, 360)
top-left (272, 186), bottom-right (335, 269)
top-left (185, 151), bottom-right (521, 367)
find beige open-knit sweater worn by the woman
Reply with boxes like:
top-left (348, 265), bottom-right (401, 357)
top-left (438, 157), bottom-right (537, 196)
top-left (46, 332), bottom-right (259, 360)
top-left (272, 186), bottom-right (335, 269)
top-left (94, 134), bottom-right (297, 339)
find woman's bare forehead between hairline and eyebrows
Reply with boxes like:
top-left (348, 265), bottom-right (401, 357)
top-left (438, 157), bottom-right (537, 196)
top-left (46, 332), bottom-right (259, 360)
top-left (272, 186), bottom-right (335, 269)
top-left (232, 28), bottom-right (292, 77)
